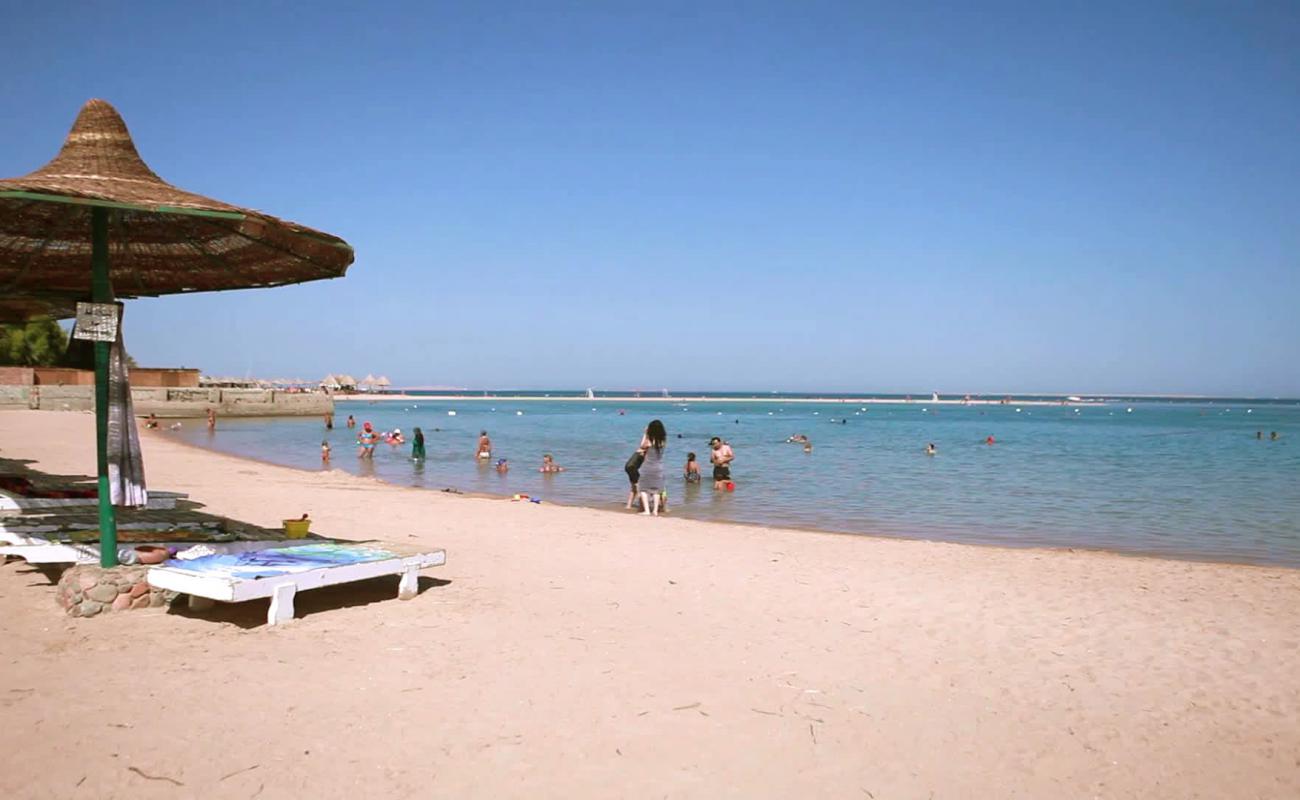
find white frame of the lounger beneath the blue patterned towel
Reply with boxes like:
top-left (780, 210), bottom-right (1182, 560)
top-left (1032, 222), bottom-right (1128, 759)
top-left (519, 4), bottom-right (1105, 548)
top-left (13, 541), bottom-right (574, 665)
top-left (150, 550), bottom-right (447, 626)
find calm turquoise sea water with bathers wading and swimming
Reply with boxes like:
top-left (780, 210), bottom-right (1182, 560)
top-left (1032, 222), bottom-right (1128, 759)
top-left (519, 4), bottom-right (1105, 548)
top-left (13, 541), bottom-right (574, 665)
top-left (182, 398), bottom-right (1300, 566)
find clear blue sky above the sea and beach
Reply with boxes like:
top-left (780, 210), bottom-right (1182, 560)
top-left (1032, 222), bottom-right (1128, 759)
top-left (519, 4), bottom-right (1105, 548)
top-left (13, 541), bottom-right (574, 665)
top-left (0, 0), bottom-right (1300, 395)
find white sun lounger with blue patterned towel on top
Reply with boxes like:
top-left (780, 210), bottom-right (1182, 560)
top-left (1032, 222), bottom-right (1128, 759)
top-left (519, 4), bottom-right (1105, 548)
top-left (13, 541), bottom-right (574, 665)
top-left (148, 541), bottom-right (447, 626)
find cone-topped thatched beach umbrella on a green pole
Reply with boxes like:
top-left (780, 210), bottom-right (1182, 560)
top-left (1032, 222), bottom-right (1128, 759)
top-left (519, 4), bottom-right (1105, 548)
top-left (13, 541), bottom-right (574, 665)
top-left (0, 100), bottom-right (352, 566)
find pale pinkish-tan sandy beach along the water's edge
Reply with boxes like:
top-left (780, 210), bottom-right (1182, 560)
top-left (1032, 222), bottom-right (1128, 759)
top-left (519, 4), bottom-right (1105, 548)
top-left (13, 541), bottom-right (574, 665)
top-left (0, 411), bottom-right (1300, 799)
